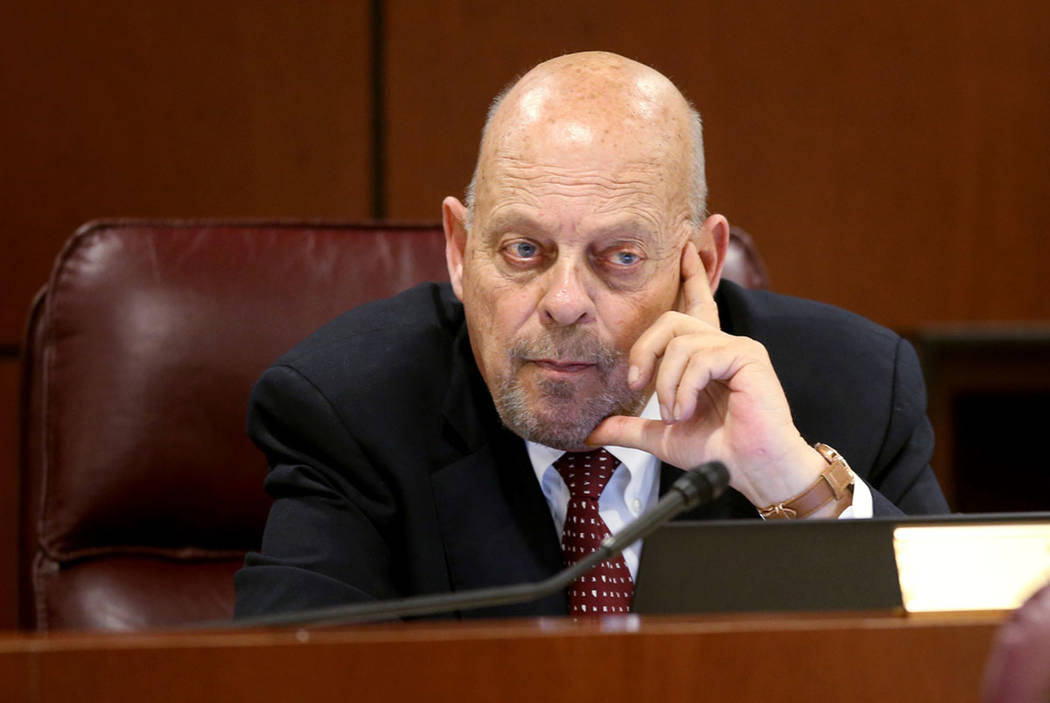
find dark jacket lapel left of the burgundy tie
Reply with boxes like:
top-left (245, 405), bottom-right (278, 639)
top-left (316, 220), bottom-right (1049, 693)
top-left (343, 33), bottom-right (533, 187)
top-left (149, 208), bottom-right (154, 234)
top-left (431, 326), bottom-right (568, 617)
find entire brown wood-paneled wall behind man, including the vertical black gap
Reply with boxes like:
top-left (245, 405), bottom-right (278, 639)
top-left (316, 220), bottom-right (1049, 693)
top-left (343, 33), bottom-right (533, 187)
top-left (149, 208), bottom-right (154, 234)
top-left (0, 0), bottom-right (1050, 626)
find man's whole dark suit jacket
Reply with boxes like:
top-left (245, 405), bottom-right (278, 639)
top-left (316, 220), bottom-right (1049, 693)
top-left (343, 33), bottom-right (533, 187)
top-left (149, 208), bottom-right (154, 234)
top-left (235, 282), bottom-right (947, 616)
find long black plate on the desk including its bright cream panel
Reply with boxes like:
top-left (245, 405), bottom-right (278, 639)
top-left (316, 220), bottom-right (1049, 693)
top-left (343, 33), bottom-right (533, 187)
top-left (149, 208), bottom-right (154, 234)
top-left (633, 513), bottom-right (1050, 615)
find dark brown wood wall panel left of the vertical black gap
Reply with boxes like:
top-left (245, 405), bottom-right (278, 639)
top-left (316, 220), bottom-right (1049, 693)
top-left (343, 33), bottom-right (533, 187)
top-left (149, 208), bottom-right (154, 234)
top-left (0, 0), bottom-right (370, 341)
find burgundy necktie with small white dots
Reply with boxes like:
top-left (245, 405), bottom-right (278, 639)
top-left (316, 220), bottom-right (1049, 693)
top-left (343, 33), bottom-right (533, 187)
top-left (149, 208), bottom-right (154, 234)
top-left (554, 449), bottom-right (634, 615)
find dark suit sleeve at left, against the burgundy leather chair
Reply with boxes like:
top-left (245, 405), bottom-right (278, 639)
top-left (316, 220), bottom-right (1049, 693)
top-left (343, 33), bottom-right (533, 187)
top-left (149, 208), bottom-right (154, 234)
top-left (234, 366), bottom-right (397, 617)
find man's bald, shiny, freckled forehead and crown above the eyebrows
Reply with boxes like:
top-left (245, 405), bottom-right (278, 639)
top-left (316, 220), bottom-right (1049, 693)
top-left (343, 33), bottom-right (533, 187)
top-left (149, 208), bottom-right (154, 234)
top-left (474, 56), bottom-right (692, 239)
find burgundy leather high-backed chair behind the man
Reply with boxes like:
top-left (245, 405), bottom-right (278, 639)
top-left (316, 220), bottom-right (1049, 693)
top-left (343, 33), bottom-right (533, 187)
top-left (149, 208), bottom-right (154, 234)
top-left (20, 221), bottom-right (768, 630)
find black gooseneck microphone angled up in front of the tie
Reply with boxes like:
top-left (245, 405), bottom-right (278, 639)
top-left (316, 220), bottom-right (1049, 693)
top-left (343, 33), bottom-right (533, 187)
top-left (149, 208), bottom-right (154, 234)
top-left (229, 462), bottom-right (729, 627)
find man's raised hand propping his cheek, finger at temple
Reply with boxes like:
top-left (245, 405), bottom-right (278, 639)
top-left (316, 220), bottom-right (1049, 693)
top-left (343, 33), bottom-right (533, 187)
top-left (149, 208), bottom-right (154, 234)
top-left (587, 242), bottom-right (826, 508)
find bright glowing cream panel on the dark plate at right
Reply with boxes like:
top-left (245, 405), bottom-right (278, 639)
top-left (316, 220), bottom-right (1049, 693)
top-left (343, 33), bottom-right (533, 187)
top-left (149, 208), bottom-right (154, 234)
top-left (894, 521), bottom-right (1050, 613)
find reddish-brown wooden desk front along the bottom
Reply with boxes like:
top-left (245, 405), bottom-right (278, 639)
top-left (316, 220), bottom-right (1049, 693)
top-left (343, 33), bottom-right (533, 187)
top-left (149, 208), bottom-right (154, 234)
top-left (0, 614), bottom-right (1002, 703)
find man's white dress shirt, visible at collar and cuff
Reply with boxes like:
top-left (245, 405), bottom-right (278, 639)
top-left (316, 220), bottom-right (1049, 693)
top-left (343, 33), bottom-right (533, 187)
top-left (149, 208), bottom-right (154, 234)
top-left (525, 393), bottom-right (873, 579)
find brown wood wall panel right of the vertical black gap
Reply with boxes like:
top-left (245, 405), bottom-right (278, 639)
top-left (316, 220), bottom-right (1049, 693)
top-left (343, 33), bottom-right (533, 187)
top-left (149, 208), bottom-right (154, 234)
top-left (385, 0), bottom-right (1050, 328)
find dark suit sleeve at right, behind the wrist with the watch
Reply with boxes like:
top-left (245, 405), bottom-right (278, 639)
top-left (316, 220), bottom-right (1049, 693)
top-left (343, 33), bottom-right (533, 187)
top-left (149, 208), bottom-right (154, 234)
top-left (867, 339), bottom-right (948, 517)
